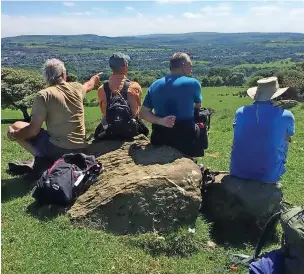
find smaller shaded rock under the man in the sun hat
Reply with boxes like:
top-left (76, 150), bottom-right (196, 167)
top-left (202, 172), bottom-right (283, 229)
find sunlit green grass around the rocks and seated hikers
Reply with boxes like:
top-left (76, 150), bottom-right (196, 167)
top-left (1, 87), bottom-right (304, 274)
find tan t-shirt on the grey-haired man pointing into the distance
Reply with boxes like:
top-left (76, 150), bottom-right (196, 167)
top-left (32, 82), bottom-right (86, 149)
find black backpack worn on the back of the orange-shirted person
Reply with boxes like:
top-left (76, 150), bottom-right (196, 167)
top-left (104, 80), bottom-right (138, 138)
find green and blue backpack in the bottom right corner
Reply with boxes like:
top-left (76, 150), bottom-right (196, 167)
top-left (227, 206), bottom-right (304, 274)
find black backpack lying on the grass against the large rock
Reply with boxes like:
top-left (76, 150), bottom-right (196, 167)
top-left (31, 153), bottom-right (102, 206)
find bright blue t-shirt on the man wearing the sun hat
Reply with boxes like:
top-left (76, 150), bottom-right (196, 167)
top-left (230, 101), bottom-right (295, 183)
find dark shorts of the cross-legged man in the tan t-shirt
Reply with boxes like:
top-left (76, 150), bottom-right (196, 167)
top-left (26, 129), bottom-right (84, 161)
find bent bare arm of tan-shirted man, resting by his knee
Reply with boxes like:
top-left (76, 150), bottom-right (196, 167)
top-left (7, 116), bottom-right (45, 140)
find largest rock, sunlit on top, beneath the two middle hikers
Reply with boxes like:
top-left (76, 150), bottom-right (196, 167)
top-left (69, 135), bottom-right (202, 233)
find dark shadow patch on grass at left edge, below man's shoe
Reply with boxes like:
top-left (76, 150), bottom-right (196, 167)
top-left (1, 177), bottom-right (35, 202)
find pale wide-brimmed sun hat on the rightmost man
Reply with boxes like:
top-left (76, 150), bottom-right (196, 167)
top-left (247, 77), bottom-right (288, 101)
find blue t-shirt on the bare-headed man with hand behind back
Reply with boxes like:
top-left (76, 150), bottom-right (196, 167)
top-left (143, 75), bottom-right (202, 120)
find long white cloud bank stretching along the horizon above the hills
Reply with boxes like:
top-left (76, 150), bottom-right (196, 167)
top-left (1, 8), bottom-right (304, 37)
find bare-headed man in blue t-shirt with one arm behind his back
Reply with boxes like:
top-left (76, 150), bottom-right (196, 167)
top-left (140, 52), bottom-right (202, 156)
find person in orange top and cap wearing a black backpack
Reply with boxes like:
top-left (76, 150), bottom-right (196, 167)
top-left (94, 52), bottom-right (149, 140)
